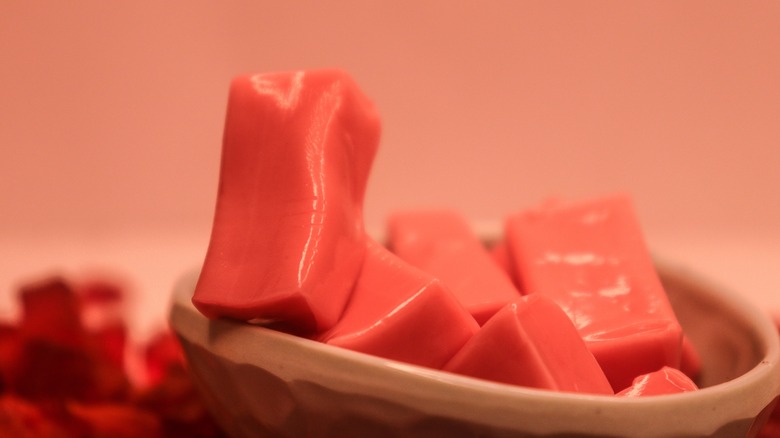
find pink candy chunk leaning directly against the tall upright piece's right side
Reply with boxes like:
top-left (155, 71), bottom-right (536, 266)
top-left (321, 241), bottom-right (479, 368)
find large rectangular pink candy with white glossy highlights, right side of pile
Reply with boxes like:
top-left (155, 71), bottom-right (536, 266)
top-left (505, 195), bottom-right (682, 391)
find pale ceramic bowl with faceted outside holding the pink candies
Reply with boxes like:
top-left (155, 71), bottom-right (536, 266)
top-left (170, 263), bottom-right (780, 437)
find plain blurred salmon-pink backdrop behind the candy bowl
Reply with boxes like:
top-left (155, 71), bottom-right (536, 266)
top-left (0, 0), bottom-right (780, 338)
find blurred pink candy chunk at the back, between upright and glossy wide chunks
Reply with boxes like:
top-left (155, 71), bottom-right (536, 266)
top-left (388, 211), bottom-right (519, 324)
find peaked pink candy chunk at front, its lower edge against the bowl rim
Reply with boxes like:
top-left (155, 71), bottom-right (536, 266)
top-left (444, 294), bottom-right (614, 395)
